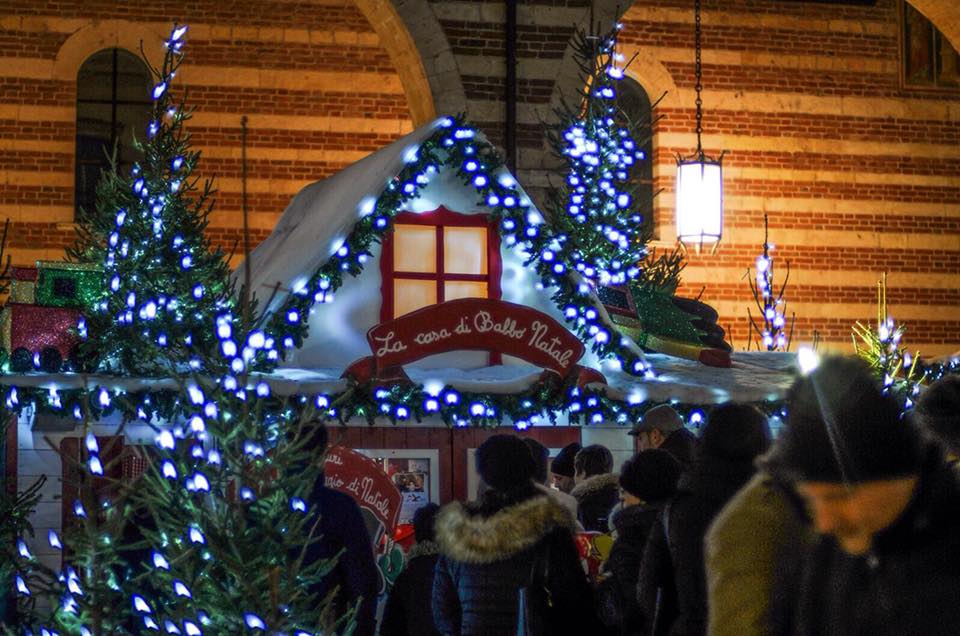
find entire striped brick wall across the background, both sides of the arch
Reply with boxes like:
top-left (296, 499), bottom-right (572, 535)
top-left (0, 0), bottom-right (960, 354)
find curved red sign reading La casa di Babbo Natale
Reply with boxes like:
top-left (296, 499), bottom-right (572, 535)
top-left (367, 298), bottom-right (584, 376)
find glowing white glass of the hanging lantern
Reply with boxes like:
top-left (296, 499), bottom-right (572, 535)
top-left (677, 162), bottom-right (723, 243)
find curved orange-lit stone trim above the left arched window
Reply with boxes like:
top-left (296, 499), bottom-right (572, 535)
top-left (53, 20), bottom-right (169, 82)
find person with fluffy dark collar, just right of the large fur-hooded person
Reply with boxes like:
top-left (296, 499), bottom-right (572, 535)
top-left (570, 444), bottom-right (620, 533)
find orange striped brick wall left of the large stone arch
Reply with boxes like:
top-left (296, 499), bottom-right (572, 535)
top-left (0, 0), bottom-right (413, 265)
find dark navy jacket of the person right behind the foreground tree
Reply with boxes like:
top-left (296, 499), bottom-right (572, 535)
top-left (304, 475), bottom-right (380, 636)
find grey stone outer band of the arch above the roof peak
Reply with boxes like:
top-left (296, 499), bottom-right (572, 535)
top-left (386, 0), bottom-right (467, 115)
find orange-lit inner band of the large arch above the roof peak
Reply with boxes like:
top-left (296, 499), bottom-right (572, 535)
top-left (354, 0), bottom-right (436, 128)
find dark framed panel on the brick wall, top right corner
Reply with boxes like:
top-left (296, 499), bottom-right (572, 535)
top-left (901, 2), bottom-right (960, 89)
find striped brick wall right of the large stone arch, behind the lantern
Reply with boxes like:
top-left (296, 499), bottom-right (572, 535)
top-left (432, 0), bottom-right (960, 354)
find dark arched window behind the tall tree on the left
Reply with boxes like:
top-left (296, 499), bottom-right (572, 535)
top-left (75, 49), bottom-right (151, 220)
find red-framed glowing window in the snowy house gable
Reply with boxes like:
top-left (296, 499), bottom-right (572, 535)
top-left (380, 208), bottom-right (501, 320)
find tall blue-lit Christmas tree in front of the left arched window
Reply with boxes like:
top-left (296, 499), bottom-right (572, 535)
top-left (69, 26), bottom-right (233, 375)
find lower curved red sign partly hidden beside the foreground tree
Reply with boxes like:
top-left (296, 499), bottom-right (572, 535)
top-left (323, 446), bottom-right (403, 534)
